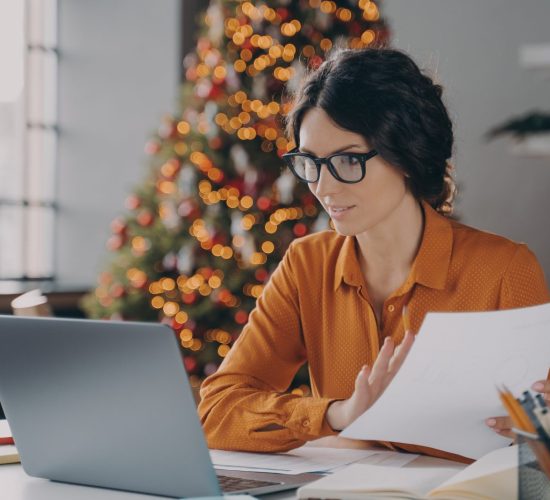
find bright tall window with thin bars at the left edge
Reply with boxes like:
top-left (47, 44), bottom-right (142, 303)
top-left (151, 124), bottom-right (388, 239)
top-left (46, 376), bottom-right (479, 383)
top-left (0, 0), bottom-right (58, 280)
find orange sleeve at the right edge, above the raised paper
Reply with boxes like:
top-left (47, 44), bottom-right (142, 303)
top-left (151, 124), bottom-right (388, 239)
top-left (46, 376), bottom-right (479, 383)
top-left (499, 244), bottom-right (550, 309)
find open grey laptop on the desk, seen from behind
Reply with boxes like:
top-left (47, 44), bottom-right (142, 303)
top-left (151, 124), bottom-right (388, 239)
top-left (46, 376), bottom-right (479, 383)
top-left (0, 316), bottom-right (319, 497)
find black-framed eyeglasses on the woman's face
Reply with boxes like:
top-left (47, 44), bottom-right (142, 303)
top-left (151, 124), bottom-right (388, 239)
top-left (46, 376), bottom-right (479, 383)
top-left (282, 148), bottom-right (378, 184)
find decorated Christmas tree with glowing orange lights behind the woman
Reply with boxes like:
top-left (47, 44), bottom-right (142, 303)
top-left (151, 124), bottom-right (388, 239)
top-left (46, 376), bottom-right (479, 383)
top-left (84, 0), bottom-right (387, 390)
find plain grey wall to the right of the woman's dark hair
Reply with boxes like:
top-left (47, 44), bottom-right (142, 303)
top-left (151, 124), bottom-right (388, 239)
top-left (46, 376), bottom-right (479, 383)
top-left (383, 0), bottom-right (550, 279)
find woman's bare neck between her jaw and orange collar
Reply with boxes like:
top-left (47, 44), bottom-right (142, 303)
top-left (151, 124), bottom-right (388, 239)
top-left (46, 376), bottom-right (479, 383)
top-left (356, 193), bottom-right (424, 276)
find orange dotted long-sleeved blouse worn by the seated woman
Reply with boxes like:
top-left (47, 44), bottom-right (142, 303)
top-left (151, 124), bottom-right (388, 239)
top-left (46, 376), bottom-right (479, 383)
top-left (199, 203), bottom-right (550, 458)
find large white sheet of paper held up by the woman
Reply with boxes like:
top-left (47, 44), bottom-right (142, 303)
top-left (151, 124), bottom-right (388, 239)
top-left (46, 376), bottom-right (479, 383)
top-left (342, 304), bottom-right (550, 459)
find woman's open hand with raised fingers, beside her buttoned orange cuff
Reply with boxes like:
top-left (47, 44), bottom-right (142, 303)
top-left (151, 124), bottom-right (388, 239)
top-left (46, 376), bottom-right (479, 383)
top-left (326, 331), bottom-right (414, 431)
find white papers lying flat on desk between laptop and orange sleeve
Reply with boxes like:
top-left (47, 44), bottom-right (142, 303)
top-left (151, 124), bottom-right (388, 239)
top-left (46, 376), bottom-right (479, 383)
top-left (210, 446), bottom-right (418, 474)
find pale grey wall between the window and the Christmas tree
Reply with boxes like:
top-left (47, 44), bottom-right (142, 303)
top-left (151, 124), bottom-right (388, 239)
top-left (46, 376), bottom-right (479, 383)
top-left (56, 0), bottom-right (181, 286)
